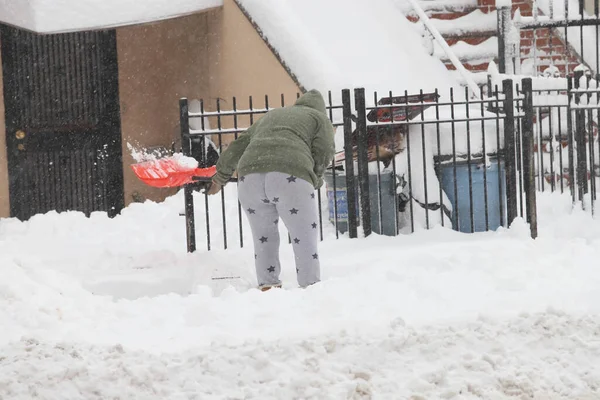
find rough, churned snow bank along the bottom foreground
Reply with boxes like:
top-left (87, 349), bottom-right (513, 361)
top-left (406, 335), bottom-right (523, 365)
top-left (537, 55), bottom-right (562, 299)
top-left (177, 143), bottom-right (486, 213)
top-left (0, 310), bottom-right (600, 400)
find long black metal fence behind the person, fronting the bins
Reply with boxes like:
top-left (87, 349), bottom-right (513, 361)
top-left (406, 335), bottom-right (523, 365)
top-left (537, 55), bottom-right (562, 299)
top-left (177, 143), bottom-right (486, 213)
top-left (180, 79), bottom-right (537, 252)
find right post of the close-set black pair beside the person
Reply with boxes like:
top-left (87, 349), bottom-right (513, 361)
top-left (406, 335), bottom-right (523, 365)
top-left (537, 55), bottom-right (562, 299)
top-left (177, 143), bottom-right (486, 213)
top-left (354, 88), bottom-right (372, 237)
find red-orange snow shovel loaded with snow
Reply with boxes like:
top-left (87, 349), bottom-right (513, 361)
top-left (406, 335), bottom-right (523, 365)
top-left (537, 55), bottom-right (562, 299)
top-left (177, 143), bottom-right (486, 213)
top-left (131, 157), bottom-right (217, 188)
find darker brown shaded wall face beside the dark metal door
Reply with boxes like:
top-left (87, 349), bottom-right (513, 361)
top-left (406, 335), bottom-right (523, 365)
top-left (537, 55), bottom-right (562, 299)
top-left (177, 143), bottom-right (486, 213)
top-left (117, 11), bottom-right (215, 205)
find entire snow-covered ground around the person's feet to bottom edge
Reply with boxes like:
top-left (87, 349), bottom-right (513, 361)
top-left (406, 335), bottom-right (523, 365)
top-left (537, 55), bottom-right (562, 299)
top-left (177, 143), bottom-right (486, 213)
top-left (0, 189), bottom-right (600, 400)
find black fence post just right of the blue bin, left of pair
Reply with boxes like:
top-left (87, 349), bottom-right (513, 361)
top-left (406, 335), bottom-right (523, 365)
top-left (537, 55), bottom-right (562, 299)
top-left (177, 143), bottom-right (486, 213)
top-left (502, 79), bottom-right (517, 226)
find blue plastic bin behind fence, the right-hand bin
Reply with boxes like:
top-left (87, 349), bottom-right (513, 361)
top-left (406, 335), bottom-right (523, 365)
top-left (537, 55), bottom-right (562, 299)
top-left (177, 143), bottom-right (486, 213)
top-left (436, 158), bottom-right (506, 233)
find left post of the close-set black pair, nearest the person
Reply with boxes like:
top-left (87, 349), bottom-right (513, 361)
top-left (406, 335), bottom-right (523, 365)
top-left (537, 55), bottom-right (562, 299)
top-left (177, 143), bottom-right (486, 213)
top-left (342, 89), bottom-right (358, 238)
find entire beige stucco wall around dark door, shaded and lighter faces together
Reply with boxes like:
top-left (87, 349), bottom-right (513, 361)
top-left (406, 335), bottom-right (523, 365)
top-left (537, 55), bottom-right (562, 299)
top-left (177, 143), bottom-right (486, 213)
top-left (0, 0), bottom-right (300, 217)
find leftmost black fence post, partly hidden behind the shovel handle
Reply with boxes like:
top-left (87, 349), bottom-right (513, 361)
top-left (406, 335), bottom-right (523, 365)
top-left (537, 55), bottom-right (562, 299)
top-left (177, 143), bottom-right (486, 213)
top-left (179, 98), bottom-right (196, 253)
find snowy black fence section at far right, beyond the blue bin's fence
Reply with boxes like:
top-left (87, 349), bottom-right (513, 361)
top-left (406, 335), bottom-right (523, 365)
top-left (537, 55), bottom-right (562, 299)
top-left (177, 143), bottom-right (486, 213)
top-left (534, 71), bottom-right (600, 209)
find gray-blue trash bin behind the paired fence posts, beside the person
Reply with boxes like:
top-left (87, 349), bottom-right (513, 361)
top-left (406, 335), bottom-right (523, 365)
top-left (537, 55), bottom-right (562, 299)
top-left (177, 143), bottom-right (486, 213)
top-left (324, 171), bottom-right (397, 236)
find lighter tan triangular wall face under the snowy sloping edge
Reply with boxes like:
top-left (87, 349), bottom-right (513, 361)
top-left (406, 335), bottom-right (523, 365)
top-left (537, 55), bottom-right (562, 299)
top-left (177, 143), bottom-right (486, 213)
top-left (205, 0), bottom-right (300, 148)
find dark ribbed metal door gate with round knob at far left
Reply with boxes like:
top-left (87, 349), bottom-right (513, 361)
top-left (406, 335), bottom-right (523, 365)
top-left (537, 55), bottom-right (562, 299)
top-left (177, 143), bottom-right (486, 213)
top-left (0, 26), bottom-right (123, 219)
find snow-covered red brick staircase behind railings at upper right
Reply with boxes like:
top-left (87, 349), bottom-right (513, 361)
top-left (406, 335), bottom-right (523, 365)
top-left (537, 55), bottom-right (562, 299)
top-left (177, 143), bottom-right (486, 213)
top-left (405, 0), bottom-right (580, 84)
